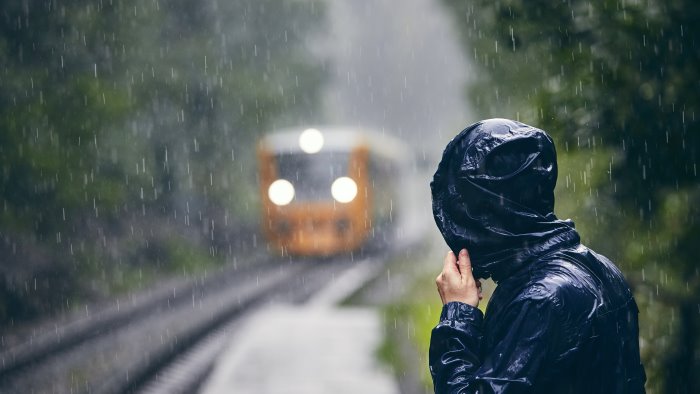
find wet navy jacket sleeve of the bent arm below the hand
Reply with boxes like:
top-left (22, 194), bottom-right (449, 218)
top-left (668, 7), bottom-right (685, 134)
top-left (429, 299), bottom-right (565, 394)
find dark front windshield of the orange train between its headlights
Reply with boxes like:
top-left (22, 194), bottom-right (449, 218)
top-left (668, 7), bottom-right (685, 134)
top-left (275, 152), bottom-right (349, 201)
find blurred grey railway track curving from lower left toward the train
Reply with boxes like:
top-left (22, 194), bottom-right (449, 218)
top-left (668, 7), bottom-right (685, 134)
top-left (0, 252), bottom-right (388, 393)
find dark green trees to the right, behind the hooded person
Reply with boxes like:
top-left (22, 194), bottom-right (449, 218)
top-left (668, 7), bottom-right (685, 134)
top-left (444, 0), bottom-right (700, 393)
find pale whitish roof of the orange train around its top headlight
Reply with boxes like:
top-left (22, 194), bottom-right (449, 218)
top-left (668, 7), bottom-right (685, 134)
top-left (261, 126), bottom-right (409, 161)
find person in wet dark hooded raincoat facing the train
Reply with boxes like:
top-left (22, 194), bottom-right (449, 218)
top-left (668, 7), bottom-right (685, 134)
top-left (429, 119), bottom-right (646, 394)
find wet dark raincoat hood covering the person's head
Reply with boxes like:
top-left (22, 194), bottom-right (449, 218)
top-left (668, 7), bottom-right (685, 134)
top-left (430, 119), bottom-right (579, 281)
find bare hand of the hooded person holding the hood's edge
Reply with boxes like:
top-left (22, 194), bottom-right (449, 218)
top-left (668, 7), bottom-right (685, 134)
top-left (435, 249), bottom-right (483, 308)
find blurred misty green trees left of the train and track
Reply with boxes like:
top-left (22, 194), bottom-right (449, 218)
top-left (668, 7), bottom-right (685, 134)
top-left (0, 0), bottom-right (324, 325)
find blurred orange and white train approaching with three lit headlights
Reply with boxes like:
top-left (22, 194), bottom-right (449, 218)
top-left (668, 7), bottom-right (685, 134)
top-left (258, 127), bottom-right (408, 256)
